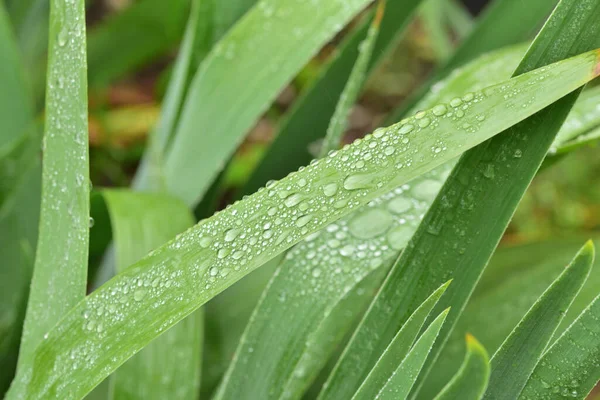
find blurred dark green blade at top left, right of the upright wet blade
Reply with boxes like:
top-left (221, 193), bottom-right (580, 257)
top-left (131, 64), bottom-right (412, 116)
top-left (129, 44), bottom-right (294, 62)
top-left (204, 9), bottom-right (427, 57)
top-left (88, 0), bottom-right (189, 86)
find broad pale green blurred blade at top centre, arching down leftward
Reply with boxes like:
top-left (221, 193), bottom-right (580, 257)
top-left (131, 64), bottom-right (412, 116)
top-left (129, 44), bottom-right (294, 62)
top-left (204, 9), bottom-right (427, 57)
top-left (165, 0), bottom-right (380, 205)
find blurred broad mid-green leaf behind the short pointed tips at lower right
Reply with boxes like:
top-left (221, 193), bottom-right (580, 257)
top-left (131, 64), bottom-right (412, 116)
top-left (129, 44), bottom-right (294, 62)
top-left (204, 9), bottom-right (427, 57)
top-left (418, 236), bottom-right (600, 399)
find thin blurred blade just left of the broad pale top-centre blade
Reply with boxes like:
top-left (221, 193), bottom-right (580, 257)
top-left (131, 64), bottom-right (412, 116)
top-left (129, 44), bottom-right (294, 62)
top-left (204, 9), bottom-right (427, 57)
top-left (132, 0), bottom-right (212, 191)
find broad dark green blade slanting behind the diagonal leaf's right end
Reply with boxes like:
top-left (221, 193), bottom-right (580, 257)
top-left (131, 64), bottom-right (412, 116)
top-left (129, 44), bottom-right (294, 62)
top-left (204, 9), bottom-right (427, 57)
top-left (323, 1), bottom-right (600, 398)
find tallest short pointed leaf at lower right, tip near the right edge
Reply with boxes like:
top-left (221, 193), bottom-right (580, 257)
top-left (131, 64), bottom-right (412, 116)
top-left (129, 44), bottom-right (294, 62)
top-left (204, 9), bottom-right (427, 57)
top-left (484, 241), bottom-right (594, 399)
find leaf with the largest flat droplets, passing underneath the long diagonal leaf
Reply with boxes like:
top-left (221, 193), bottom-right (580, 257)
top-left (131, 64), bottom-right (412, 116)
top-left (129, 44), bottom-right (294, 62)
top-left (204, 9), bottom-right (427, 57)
top-left (216, 43), bottom-right (600, 395)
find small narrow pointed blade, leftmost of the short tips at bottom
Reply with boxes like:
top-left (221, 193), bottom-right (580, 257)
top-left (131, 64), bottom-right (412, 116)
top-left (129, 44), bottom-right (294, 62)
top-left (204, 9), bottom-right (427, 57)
top-left (352, 282), bottom-right (450, 400)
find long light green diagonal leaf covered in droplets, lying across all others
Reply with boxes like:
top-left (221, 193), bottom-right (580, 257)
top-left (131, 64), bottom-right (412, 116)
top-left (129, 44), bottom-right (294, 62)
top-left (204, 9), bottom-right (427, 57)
top-left (9, 52), bottom-right (599, 399)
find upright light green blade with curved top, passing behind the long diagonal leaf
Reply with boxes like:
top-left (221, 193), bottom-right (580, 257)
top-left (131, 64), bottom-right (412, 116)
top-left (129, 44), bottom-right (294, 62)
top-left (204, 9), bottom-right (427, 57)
top-left (103, 190), bottom-right (202, 400)
